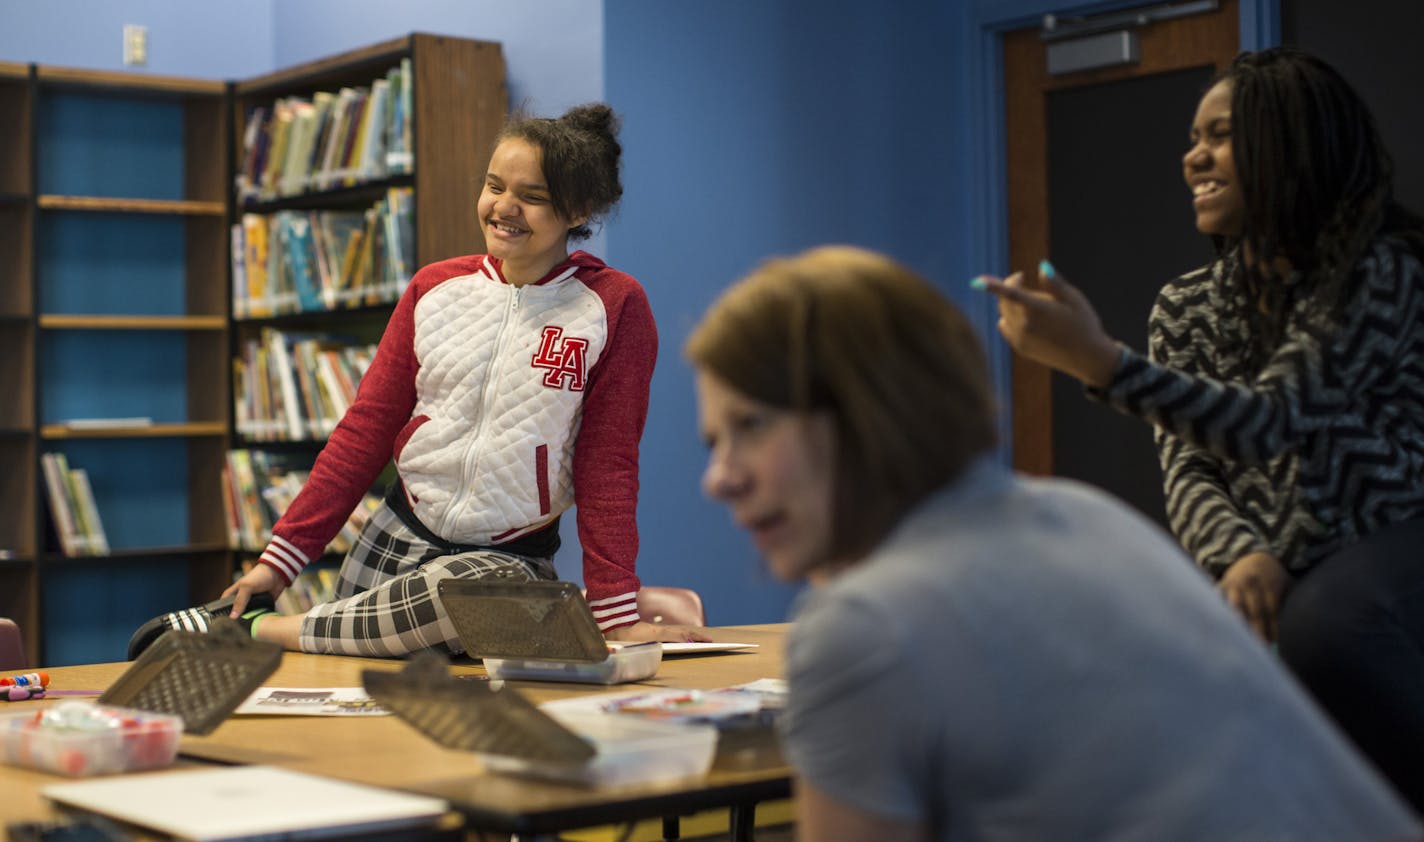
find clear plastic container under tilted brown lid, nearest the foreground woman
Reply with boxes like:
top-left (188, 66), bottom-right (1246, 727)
top-left (480, 711), bottom-right (718, 786)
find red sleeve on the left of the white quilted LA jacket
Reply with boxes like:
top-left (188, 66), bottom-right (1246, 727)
top-left (261, 268), bottom-right (430, 584)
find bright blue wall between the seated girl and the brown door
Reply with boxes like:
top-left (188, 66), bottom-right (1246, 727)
top-left (604, 0), bottom-right (973, 624)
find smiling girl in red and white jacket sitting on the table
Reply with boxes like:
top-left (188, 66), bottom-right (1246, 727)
top-left (128, 103), bottom-right (706, 658)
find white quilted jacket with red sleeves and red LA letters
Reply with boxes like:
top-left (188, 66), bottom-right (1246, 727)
top-left (261, 252), bottom-right (658, 631)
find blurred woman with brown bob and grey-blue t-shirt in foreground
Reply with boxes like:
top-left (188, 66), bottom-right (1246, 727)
top-left (686, 248), bottom-right (1420, 842)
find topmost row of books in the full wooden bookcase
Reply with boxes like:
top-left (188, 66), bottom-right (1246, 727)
top-left (235, 58), bottom-right (416, 205)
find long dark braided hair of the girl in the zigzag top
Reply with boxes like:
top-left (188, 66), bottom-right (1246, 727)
top-left (1212, 47), bottom-right (1424, 363)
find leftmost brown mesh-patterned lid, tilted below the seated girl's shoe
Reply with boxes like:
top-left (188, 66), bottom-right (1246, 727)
top-left (98, 617), bottom-right (282, 735)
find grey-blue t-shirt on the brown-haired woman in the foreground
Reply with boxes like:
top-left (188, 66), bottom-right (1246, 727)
top-left (782, 459), bottom-right (1421, 842)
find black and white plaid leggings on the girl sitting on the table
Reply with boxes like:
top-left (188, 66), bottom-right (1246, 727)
top-left (299, 503), bottom-right (557, 658)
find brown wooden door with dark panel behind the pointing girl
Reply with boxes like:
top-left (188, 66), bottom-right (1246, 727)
top-left (1004, 0), bottom-right (1239, 523)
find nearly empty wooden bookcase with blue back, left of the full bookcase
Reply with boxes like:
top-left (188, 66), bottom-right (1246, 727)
top-left (22, 66), bottom-right (232, 665)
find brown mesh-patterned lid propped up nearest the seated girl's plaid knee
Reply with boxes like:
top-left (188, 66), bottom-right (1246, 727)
top-left (436, 578), bottom-right (608, 664)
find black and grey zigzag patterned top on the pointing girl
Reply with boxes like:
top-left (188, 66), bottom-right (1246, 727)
top-left (1095, 238), bottom-right (1424, 576)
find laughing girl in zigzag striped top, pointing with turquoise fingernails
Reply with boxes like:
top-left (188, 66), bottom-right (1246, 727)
top-left (980, 48), bottom-right (1424, 811)
